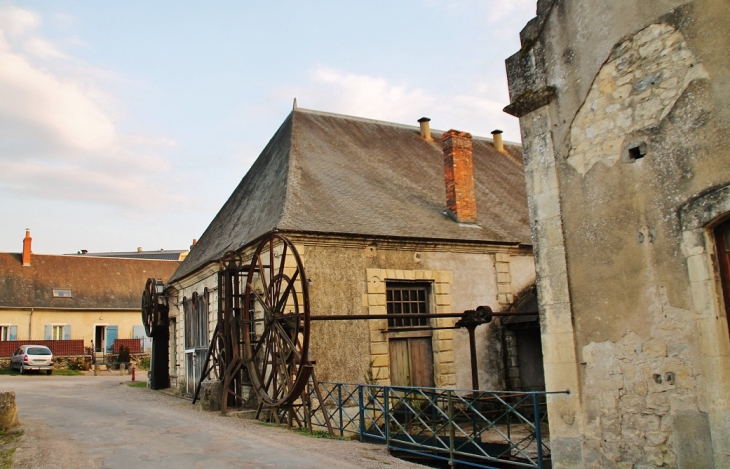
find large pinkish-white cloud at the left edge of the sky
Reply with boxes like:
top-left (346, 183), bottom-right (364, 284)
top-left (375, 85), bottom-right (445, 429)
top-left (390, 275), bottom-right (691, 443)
top-left (0, 7), bottom-right (185, 210)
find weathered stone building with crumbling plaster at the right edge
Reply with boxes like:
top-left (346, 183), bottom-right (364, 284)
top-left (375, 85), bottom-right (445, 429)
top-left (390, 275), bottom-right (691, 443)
top-left (505, 0), bottom-right (730, 468)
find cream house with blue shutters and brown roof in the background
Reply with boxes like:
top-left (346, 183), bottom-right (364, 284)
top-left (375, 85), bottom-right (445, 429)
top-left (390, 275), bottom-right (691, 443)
top-left (0, 231), bottom-right (180, 358)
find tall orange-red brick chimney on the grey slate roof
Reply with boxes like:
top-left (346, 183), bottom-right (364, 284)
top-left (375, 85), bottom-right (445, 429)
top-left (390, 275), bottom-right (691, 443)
top-left (441, 129), bottom-right (477, 223)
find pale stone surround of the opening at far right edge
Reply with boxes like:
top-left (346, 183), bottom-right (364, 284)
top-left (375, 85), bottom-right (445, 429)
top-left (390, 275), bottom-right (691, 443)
top-left (679, 184), bottom-right (730, 454)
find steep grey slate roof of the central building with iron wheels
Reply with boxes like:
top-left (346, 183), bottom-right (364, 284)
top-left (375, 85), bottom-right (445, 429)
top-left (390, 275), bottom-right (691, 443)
top-left (171, 108), bottom-right (531, 281)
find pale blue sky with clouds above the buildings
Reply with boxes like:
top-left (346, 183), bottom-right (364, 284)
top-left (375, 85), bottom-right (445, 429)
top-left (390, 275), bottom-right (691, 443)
top-left (0, 0), bottom-right (535, 254)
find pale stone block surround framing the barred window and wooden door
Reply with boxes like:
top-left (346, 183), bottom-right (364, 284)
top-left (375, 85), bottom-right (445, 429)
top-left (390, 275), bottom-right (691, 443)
top-left (363, 269), bottom-right (456, 387)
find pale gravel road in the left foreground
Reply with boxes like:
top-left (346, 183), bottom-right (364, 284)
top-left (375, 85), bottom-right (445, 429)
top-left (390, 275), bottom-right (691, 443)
top-left (0, 375), bottom-right (424, 469)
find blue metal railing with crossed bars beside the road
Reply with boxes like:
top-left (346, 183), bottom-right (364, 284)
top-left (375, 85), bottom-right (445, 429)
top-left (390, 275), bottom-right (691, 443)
top-left (310, 382), bottom-right (550, 469)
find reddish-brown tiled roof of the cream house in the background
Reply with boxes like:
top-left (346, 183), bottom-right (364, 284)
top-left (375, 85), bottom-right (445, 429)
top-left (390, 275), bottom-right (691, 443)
top-left (0, 253), bottom-right (180, 309)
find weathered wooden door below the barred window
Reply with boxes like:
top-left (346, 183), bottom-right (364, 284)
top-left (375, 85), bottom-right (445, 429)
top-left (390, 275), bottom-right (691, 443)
top-left (389, 337), bottom-right (434, 387)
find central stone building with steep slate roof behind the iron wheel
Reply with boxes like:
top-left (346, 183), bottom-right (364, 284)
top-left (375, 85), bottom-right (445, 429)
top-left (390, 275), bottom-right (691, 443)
top-left (167, 107), bottom-right (535, 393)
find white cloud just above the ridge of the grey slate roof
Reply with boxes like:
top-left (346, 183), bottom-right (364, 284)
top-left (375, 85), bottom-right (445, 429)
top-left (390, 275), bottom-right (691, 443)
top-left (276, 68), bottom-right (520, 141)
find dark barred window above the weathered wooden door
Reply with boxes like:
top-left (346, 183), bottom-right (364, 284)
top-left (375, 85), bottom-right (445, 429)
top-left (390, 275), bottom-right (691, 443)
top-left (385, 283), bottom-right (431, 329)
